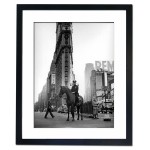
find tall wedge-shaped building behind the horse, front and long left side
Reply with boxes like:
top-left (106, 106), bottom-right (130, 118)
top-left (44, 22), bottom-right (75, 107)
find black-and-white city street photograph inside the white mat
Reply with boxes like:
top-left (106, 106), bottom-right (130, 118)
top-left (33, 22), bottom-right (115, 128)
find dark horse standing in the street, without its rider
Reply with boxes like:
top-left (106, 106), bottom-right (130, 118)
top-left (59, 86), bottom-right (83, 121)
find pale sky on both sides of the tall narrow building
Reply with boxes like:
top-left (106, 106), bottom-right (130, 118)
top-left (34, 23), bottom-right (114, 101)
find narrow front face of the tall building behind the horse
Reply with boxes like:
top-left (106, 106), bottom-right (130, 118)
top-left (54, 22), bottom-right (74, 98)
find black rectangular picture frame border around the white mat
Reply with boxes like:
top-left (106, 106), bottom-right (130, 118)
top-left (16, 4), bottom-right (132, 146)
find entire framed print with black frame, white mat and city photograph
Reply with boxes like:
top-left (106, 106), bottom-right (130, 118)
top-left (16, 4), bottom-right (132, 146)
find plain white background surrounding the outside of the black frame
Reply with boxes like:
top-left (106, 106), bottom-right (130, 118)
top-left (0, 0), bottom-right (150, 150)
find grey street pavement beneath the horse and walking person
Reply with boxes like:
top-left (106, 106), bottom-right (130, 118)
top-left (34, 112), bottom-right (114, 128)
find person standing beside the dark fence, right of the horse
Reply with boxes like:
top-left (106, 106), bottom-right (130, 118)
top-left (92, 96), bottom-right (98, 119)
